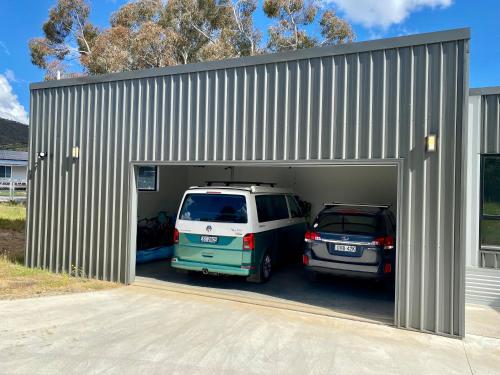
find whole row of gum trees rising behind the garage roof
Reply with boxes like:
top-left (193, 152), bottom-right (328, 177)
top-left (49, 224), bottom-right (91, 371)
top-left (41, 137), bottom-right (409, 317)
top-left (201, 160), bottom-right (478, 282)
top-left (29, 0), bottom-right (354, 79)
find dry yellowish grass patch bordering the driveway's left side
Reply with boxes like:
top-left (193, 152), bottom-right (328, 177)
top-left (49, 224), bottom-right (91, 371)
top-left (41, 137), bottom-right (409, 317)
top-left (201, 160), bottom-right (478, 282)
top-left (0, 256), bottom-right (119, 299)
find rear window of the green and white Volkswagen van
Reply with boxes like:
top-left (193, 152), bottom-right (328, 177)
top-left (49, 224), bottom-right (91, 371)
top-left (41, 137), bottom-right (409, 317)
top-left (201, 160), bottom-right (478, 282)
top-left (179, 194), bottom-right (248, 223)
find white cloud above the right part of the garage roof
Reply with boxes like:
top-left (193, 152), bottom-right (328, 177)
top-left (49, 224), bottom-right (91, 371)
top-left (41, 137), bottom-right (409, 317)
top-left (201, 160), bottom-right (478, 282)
top-left (325, 0), bottom-right (453, 29)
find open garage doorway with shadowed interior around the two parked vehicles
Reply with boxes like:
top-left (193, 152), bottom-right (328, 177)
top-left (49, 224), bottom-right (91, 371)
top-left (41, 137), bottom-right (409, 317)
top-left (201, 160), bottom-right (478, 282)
top-left (131, 164), bottom-right (398, 324)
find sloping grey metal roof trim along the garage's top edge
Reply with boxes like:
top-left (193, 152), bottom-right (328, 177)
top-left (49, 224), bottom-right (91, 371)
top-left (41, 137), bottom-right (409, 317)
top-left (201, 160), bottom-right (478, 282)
top-left (30, 28), bottom-right (470, 90)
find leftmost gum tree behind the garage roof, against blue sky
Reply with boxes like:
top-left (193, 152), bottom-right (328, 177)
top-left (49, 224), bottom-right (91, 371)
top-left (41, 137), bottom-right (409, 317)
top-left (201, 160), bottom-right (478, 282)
top-left (29, 0), bottom-right (98, 76)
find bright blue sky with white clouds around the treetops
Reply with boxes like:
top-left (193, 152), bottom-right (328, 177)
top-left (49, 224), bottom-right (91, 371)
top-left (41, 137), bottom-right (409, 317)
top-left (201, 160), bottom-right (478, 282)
top-left (0, 0), bottom-right (500, 122)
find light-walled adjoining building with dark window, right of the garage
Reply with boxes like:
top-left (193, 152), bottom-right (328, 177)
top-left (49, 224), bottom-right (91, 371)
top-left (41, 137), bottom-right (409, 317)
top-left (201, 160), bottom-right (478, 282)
top-left (466, 87), bottom-right (500, 306)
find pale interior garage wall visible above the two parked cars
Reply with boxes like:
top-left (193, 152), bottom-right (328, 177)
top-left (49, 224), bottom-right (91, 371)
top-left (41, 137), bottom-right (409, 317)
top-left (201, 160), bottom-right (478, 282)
top-left (137, 166), bottom-right (398, 219)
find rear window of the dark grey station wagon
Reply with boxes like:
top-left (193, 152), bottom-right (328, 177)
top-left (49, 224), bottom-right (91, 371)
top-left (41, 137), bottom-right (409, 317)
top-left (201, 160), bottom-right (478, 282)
top-left (315, 213), bottom-right (384, 235)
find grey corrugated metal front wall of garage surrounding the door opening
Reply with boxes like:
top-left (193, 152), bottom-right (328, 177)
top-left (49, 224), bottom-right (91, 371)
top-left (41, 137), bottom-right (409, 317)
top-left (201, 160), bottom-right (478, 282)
top-left (27, 30), bottom-right (469, 335)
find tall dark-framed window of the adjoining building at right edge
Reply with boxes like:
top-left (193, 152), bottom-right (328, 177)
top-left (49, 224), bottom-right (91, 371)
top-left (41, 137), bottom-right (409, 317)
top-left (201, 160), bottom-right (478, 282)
top-left (480, 155), bottom-right (500, 249)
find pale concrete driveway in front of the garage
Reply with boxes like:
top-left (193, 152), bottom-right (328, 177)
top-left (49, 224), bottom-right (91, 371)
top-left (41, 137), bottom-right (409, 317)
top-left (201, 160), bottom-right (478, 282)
top-left (0, 286), bottom-right (500, 375)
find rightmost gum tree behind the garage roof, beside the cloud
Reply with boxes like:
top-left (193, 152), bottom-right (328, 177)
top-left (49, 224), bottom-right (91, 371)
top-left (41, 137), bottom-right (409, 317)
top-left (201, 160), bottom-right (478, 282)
top-left (263, 0), bottom-right (354, 51)
